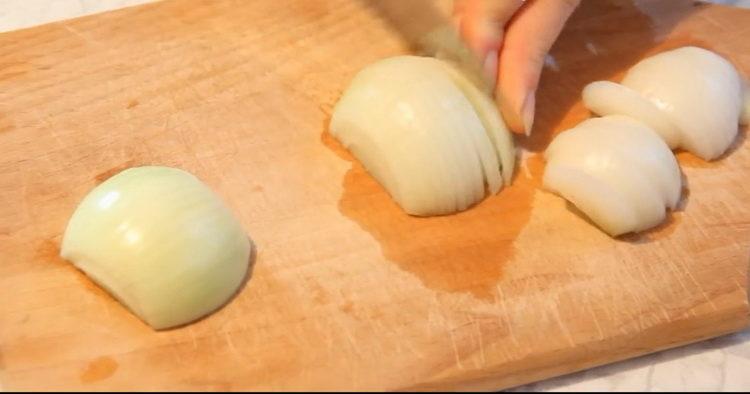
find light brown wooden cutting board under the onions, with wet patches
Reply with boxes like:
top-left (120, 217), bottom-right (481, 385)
top-left (0, 0), bottom-right (750, 390)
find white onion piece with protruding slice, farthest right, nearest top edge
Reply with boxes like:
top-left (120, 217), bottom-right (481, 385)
top-left (583, 47), bottom-right (746, 160)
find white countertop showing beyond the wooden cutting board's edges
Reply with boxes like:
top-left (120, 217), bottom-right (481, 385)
top-left (0, 0), bottom-right (750, 391)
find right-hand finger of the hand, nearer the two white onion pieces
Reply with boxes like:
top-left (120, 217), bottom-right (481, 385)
top-left (497, 0), bottom-right (580, 134)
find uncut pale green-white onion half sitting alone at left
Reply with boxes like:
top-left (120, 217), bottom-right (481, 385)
top-left (60, 166), bottom-right (251, 329)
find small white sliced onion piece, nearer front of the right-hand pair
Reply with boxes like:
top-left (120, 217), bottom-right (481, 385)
top-left (543, 115), bottom-right (682, 236)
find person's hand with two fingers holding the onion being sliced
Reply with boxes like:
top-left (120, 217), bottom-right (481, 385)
top-left (454, 0), bottom-right (580, 134)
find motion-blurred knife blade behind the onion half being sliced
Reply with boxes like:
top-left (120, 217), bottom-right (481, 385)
top-left (363, 0), bottom-right (494, 97)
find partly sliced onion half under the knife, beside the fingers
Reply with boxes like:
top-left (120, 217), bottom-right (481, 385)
top-left (330, 56), bottom-right (515, 216)
